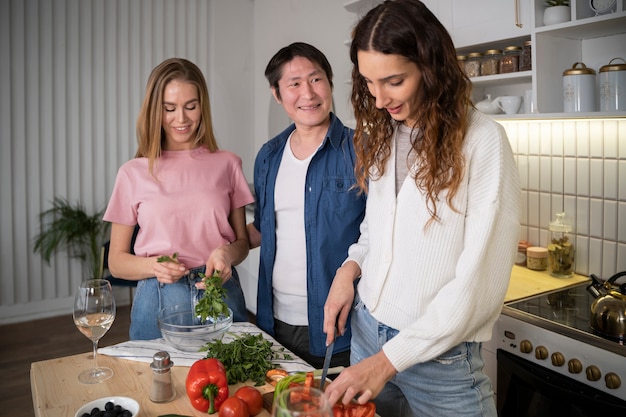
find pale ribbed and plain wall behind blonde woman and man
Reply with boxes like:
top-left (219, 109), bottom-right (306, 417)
top-left (0, 0), bottom-right (353, 324)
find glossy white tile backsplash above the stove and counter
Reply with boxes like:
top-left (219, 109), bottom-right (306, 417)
top-left (501, 118), bottom-right (626, 278)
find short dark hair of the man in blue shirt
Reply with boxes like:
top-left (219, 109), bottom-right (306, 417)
top-left (265, 42), bottom-right (333, 98)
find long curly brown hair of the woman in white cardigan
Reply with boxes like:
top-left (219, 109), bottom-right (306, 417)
top-left (350, 0), bottom-right (472, 220)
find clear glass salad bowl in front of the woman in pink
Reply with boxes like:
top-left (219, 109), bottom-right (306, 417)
top-left (157, 304), bottom-right (233, 352)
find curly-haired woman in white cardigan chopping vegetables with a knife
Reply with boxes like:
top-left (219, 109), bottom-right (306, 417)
top-left (324, 0), bottom-right (520, 417)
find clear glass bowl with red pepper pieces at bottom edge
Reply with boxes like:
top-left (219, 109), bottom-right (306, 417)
top-left (272, 386), bottom-right (333, 417)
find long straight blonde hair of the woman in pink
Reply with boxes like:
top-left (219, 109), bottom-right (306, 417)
top-left (135, 58), bottom-right (218, 175)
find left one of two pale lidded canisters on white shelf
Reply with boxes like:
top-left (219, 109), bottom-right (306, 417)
top-left (563, 62), bottom-right (596, 113)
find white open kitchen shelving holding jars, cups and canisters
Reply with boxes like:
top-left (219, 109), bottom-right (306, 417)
top-left (458, 0), bottom-right (626, 118)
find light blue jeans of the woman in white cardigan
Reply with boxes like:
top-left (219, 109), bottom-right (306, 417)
top-left (350, 302), bottom-right (497, 417)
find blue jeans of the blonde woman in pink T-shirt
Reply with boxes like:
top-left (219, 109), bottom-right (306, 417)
top-left (129, 267), bottom-right (248, 340)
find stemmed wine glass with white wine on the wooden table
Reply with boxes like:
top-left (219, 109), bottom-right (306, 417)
top-left (74, 279), bottom-right (115, 384)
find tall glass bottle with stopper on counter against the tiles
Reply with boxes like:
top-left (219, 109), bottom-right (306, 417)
top-left (548, 213), bottom-right (575, 278)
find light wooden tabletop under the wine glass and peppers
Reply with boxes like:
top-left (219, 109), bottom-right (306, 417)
top-left (30, 353), bottom-right (273, 417)
